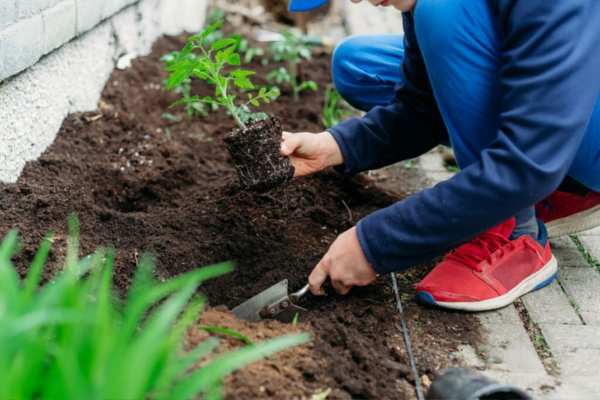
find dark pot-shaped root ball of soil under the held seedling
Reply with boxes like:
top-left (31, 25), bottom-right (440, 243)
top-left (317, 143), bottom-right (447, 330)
top-left (224, 117), bottom-right (294, 190)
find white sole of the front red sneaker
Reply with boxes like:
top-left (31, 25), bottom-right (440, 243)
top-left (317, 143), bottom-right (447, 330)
top-left (426, 256), bottom-right (558, 312)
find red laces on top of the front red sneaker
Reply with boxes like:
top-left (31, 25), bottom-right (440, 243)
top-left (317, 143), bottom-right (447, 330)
top-left (446, 231), bottom-right (515, 272)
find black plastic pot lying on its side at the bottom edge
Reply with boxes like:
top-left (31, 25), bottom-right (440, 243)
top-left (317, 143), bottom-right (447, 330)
top-left (427, 368), bottom-right (533, 400)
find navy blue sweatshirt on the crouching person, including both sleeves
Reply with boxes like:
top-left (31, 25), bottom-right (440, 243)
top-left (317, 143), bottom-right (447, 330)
top-left (330, 0), bottom-right (600, 273)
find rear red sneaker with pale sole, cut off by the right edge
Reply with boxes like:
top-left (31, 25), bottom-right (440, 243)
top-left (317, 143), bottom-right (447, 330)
top-left (535, 190), bottom-right (600, 238)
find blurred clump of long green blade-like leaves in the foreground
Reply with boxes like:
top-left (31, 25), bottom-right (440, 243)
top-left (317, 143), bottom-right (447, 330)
top-left (0, 218), bottom-right (307, 400)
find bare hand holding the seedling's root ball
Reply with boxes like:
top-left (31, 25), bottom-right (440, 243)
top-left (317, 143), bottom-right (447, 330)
top-left (281, 131), bottom-right (344, 176)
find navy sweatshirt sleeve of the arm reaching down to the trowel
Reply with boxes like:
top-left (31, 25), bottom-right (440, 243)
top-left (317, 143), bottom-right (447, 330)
top-left (358, 0), bottom-right (600, 273)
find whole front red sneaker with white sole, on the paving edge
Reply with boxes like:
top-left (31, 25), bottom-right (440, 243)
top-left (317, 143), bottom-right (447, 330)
top-left (416, 218), bottom-right (557, 311)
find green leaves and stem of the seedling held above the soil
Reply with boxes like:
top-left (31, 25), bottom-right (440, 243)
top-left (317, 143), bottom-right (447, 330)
top-left (167, 21), bottom-right (279, 128)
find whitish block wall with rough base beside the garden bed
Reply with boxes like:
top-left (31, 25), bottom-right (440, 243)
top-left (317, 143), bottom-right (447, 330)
top-left (0, 0), bottom-right (207, 182)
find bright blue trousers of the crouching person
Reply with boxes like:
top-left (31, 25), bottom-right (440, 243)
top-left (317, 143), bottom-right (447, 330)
top-left (332, 0), bottom-right (600, 191)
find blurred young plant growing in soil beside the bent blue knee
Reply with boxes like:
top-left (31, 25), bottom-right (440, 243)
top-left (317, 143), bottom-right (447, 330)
top-left (267, 30), bottom-right (318, 100)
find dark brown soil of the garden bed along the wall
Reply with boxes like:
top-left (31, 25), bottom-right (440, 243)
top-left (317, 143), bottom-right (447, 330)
top-left (0, 32), bottom-right (478, 399)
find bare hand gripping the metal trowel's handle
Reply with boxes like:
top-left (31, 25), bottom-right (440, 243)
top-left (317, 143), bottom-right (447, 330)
top-left (308, 227), bottom-right (377, 296)
